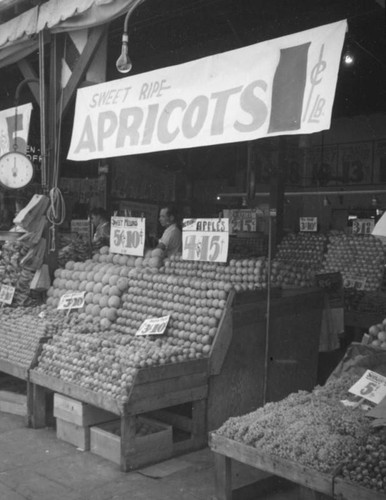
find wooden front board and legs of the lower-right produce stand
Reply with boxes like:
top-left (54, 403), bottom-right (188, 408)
top-left (209, 432), bottom-right (334, 500)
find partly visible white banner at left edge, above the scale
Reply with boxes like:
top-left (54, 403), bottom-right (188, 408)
top-left (0, 103), bottom-right (32, 156)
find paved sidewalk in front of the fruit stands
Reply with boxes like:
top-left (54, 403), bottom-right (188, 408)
top-left (0, 412), bottom-right (299, 500)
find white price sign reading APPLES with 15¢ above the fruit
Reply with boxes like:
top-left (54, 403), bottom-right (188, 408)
top-left (182, 219), bottom-right (229, 262)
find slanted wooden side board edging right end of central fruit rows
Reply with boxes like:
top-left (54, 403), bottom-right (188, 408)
top-left (209, 291), bottom-right (235, 375)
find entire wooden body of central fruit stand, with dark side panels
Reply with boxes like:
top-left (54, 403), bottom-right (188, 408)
top-left (29, 289), bottom-right (323, 471)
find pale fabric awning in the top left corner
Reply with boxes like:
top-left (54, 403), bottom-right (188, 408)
top-left (0, 0), bottom-right (143, 67)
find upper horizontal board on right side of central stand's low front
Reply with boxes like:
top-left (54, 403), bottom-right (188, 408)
top-left (130, 373), bottom-right (207, 401)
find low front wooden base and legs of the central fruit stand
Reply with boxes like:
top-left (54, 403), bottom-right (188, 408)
top-left (30, 359), bottom-right (208, 471)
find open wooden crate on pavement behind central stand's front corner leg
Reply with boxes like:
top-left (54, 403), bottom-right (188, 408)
top-left (90, 416), bottom-right (173, 469)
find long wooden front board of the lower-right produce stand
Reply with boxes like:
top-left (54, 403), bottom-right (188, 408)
top-left (209, 433), bottom-right (333, 497)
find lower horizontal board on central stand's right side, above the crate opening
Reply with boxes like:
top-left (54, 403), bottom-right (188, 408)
top-left (126, 385), bottom-right (208, 415)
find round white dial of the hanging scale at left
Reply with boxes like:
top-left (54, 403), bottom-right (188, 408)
top-left (0, 151), bottom-right (34, 189)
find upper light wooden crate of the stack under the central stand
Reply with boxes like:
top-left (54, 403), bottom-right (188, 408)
top-left (54, 393), bottom-right (116, 427)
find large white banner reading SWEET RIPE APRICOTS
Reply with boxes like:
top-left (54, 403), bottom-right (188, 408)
top-left (68, 20), bottom-right (347, 161)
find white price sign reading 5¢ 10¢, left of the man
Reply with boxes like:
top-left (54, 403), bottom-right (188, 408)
top-left (110, 217), bottom-right (145, 257)
